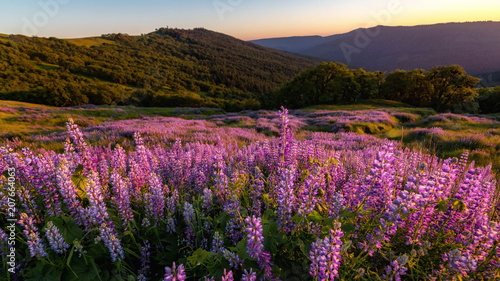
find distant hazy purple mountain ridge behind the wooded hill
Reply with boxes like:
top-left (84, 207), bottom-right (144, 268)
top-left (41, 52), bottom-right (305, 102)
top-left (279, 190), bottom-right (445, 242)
top-left (252, 22), bottom-right (500, 75)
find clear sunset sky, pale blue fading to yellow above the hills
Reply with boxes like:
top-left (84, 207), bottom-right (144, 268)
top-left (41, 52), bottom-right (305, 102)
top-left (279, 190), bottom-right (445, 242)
top-left (0, 0), bottom-right (500, 40)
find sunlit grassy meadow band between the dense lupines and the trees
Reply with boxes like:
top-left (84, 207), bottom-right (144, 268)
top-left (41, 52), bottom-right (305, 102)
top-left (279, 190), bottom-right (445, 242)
top-left (0, 100), bottom-right (500, 174)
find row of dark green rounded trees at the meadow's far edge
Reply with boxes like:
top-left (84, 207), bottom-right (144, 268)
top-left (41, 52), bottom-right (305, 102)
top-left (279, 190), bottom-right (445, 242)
top-left (263, 62), bottom-right (480, 112)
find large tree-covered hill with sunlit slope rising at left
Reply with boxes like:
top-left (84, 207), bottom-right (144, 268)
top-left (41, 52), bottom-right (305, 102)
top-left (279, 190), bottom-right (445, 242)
top-left (0, 28), bottom-right (318, 110)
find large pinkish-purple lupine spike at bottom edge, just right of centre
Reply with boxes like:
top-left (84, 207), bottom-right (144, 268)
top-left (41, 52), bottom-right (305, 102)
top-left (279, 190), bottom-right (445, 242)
top-left (309, 222), bottom-right (344, 280)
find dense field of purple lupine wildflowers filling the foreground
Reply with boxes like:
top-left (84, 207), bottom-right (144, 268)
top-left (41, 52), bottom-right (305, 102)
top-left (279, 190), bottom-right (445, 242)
top-left (0, 104), bottom-right (500, 280)
